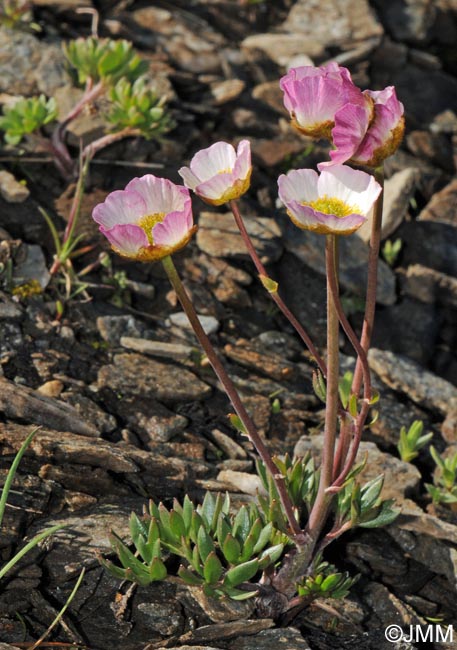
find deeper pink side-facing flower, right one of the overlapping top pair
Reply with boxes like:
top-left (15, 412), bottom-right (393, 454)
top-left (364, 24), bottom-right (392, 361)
top-left (326, 86), bottom-right (405, 168)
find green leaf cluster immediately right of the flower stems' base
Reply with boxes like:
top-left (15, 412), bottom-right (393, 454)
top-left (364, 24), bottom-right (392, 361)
top-left (336, 463), bottom-right (400, 529)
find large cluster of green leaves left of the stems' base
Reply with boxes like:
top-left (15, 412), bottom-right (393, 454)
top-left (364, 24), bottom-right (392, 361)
top-left (102, 492), bottom-right (288, 600)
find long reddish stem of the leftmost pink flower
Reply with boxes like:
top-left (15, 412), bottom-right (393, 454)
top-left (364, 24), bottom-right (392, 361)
top-left (162, 256), bottom-right (304, 544)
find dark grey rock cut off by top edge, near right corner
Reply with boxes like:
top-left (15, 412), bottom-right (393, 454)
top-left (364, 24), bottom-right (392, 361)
top-left (374, 0), bottom-right (437, 43)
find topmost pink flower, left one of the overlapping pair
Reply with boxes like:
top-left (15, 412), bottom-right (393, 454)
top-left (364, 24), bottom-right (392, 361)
top-left (279, 62), bottom-right (372, 138)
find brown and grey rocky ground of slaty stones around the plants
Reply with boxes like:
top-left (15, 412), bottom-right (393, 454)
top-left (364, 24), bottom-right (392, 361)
top-left (0, 0), bottom-right (457, 650)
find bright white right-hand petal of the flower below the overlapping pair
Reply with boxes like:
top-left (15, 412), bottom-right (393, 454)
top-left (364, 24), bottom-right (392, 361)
top-left (318, 165), bottom-right (382, 215)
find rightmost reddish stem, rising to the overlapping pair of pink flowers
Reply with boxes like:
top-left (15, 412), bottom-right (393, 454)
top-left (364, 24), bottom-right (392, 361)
top-left (352, 166), bottom-right (384, 395)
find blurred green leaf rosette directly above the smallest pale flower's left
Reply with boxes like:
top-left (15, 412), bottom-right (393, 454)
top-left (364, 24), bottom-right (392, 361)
top-left (106, 77), bottom-right (173, 139)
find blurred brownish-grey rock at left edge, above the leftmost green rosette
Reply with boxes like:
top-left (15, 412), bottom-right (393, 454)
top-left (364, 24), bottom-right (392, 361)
top-left (0, 27), bottom-right (68, 97)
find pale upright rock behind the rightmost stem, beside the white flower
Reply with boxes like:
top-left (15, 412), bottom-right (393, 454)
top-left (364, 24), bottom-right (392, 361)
top-left (357, 169), bottom-right (418, 243)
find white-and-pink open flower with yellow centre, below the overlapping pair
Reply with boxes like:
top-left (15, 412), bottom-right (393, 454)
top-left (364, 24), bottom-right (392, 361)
top-left (278, 165), bottom-right (381, 235)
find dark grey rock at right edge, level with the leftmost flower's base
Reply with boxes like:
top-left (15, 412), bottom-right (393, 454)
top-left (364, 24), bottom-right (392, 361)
top-left (396, 221), bottom-right (457, 277)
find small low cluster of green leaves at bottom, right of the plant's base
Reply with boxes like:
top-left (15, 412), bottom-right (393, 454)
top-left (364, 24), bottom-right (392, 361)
top-left (297, 557), bottom-right (359, 600)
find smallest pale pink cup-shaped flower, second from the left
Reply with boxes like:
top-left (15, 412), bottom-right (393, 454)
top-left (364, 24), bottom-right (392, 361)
top-left (178, 140), bottom-right (252, 205)
